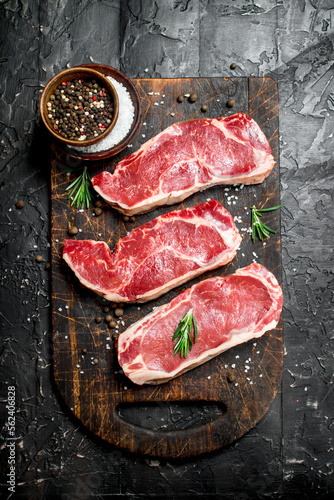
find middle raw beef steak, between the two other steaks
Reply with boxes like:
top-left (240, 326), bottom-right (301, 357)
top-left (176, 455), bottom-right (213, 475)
top-left (63, 200), bottom-right (241, 302)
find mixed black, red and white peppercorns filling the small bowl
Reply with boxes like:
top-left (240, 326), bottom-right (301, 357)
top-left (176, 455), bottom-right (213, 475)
top-left (47, 79), bottom-right (113, 141)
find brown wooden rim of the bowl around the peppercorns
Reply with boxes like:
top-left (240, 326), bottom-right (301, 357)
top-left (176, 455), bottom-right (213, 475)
top-left (40, 66), bottom-right (119, 148)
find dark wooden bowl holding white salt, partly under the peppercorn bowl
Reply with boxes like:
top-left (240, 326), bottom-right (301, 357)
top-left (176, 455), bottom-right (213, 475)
top-left (63, 63), bottom-right (141, 161)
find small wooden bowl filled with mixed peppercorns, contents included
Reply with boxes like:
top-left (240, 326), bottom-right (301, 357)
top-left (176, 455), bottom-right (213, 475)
top-left (40, 66), bottom-right (119, 146)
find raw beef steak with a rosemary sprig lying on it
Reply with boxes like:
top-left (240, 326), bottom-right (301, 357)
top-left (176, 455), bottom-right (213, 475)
top-left (117, 264), bottom-right (282, 385)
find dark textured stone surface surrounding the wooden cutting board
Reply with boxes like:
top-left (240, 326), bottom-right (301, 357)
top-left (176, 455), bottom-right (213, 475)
top-left (0, 0), bottom-right (334, 499)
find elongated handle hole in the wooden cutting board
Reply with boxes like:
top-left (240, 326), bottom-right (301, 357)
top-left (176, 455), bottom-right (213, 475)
top-left (117, 401), bottom-right (228, 431)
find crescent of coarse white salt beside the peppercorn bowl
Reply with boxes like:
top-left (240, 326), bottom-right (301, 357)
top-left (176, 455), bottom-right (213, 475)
top-left (69, 76), bottom-right (135, 153)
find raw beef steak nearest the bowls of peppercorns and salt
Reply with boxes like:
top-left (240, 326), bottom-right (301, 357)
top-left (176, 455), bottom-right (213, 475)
top-left (92, 113), bottom-right (275, 215)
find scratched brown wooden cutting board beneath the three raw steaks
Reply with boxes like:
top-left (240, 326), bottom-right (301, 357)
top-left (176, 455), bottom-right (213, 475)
top-left (51, 78), bottom-right (283, 457)
